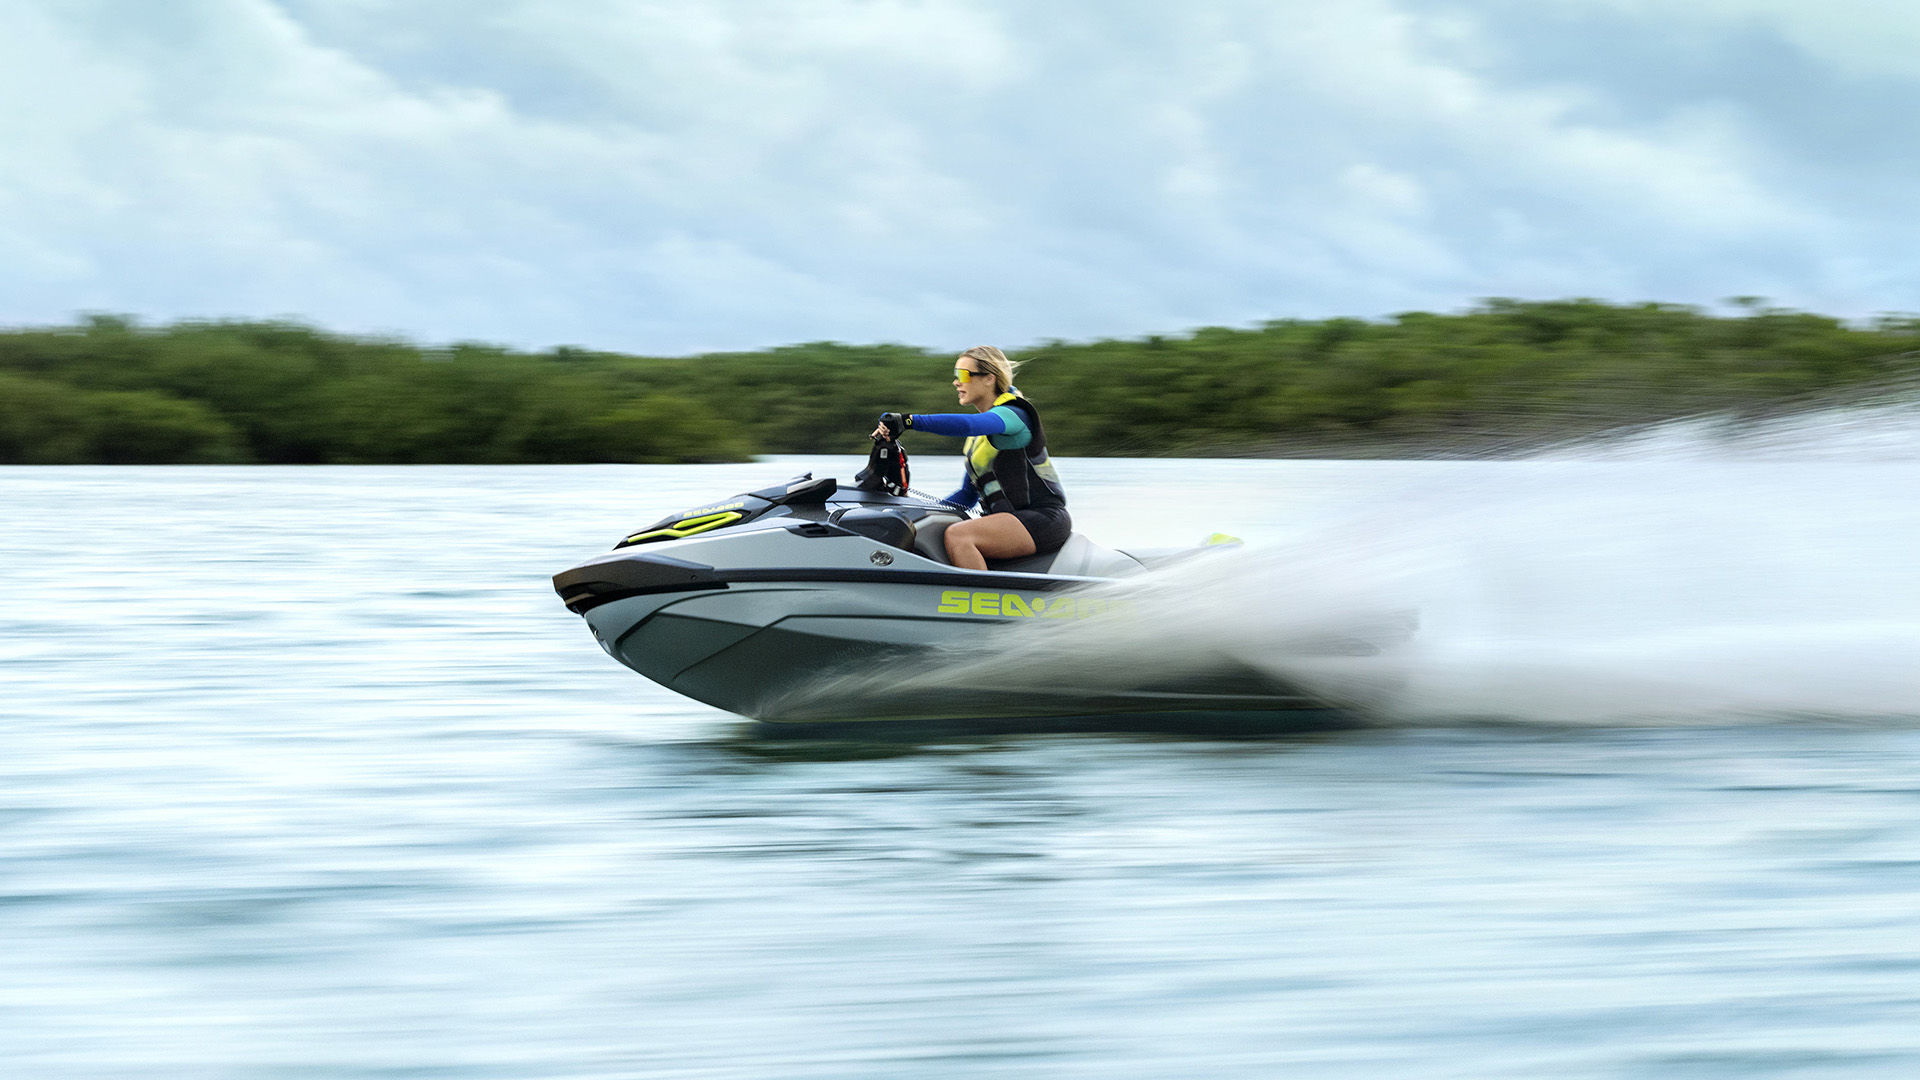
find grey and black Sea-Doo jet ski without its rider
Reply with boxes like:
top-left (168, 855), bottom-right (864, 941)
top-left (553, 440), bottom-right (1382, 728)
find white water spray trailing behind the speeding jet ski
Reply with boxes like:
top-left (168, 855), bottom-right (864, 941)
top-left (775, 407), bottom-right (1920, 723)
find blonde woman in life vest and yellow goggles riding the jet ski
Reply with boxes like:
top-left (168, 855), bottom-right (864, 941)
top-left (874, 346), bottom-right (1073, 571)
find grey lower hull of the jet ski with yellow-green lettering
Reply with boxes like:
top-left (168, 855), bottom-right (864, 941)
top-left (586, 575), bottom-right (1327, 726)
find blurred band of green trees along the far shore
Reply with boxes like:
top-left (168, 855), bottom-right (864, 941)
top-left (0, 300), bottom-right (1920, 463)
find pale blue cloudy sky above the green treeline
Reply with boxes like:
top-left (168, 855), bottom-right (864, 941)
top-left (0, 0), bottom-right (1920, 354)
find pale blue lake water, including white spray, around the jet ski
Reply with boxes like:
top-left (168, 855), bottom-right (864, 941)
top-left (0, 419), bottom-right (1920, 1080)
